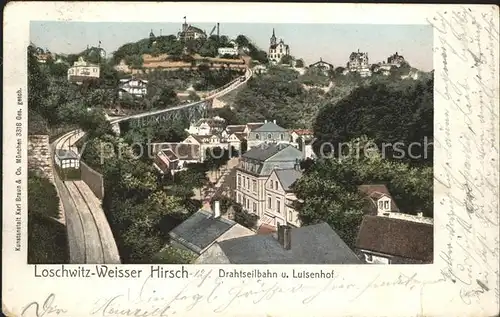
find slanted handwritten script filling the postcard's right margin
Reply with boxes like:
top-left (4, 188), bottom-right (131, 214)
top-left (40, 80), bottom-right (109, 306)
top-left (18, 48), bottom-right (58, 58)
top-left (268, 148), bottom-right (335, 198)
top-left (428, 4), bottom-right (499, 305)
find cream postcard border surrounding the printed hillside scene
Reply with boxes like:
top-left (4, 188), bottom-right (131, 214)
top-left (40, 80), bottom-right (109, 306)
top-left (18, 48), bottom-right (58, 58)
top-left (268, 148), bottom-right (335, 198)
top-left (2, 2), bottom-right (499, 317)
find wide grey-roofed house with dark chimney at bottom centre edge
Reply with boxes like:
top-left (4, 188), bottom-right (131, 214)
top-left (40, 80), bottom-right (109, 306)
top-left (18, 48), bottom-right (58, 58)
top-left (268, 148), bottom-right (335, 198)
top-left (195, 223), bottom-right (362, 264)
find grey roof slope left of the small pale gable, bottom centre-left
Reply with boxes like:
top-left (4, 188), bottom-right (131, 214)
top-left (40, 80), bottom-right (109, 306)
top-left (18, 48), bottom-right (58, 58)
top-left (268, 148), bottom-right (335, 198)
top-left (169, 209), bottom-right (236, 254)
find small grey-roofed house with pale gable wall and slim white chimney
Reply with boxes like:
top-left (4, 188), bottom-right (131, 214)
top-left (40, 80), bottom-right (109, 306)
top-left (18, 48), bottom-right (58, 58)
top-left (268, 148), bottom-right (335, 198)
top-left (168, 201), bottom-right (255, 256)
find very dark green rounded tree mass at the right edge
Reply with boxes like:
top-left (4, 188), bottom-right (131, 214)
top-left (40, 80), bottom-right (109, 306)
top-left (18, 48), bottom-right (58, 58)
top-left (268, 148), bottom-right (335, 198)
top-left (314, 79), bottom-right (433, 164)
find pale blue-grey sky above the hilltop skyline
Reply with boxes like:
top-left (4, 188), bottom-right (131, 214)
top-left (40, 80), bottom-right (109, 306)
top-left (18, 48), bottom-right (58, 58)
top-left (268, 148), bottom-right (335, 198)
top-left (30, 21), bottom-right (433, 71)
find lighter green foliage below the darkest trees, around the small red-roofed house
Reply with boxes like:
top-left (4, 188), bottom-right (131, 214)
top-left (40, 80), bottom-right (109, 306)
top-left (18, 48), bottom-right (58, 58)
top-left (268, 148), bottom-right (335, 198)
top-left (294, 137), bottom-right (433, 246)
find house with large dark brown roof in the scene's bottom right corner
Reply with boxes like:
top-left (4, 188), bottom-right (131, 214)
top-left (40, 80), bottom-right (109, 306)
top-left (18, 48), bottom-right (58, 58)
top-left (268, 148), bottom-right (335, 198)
top-left (355, 215), bottom-right (434, 264)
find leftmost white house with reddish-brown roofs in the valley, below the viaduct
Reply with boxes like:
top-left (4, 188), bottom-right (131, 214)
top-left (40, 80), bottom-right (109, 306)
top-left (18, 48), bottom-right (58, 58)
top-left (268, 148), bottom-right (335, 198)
top-left (152, 143), bottom-right (201, 174)
